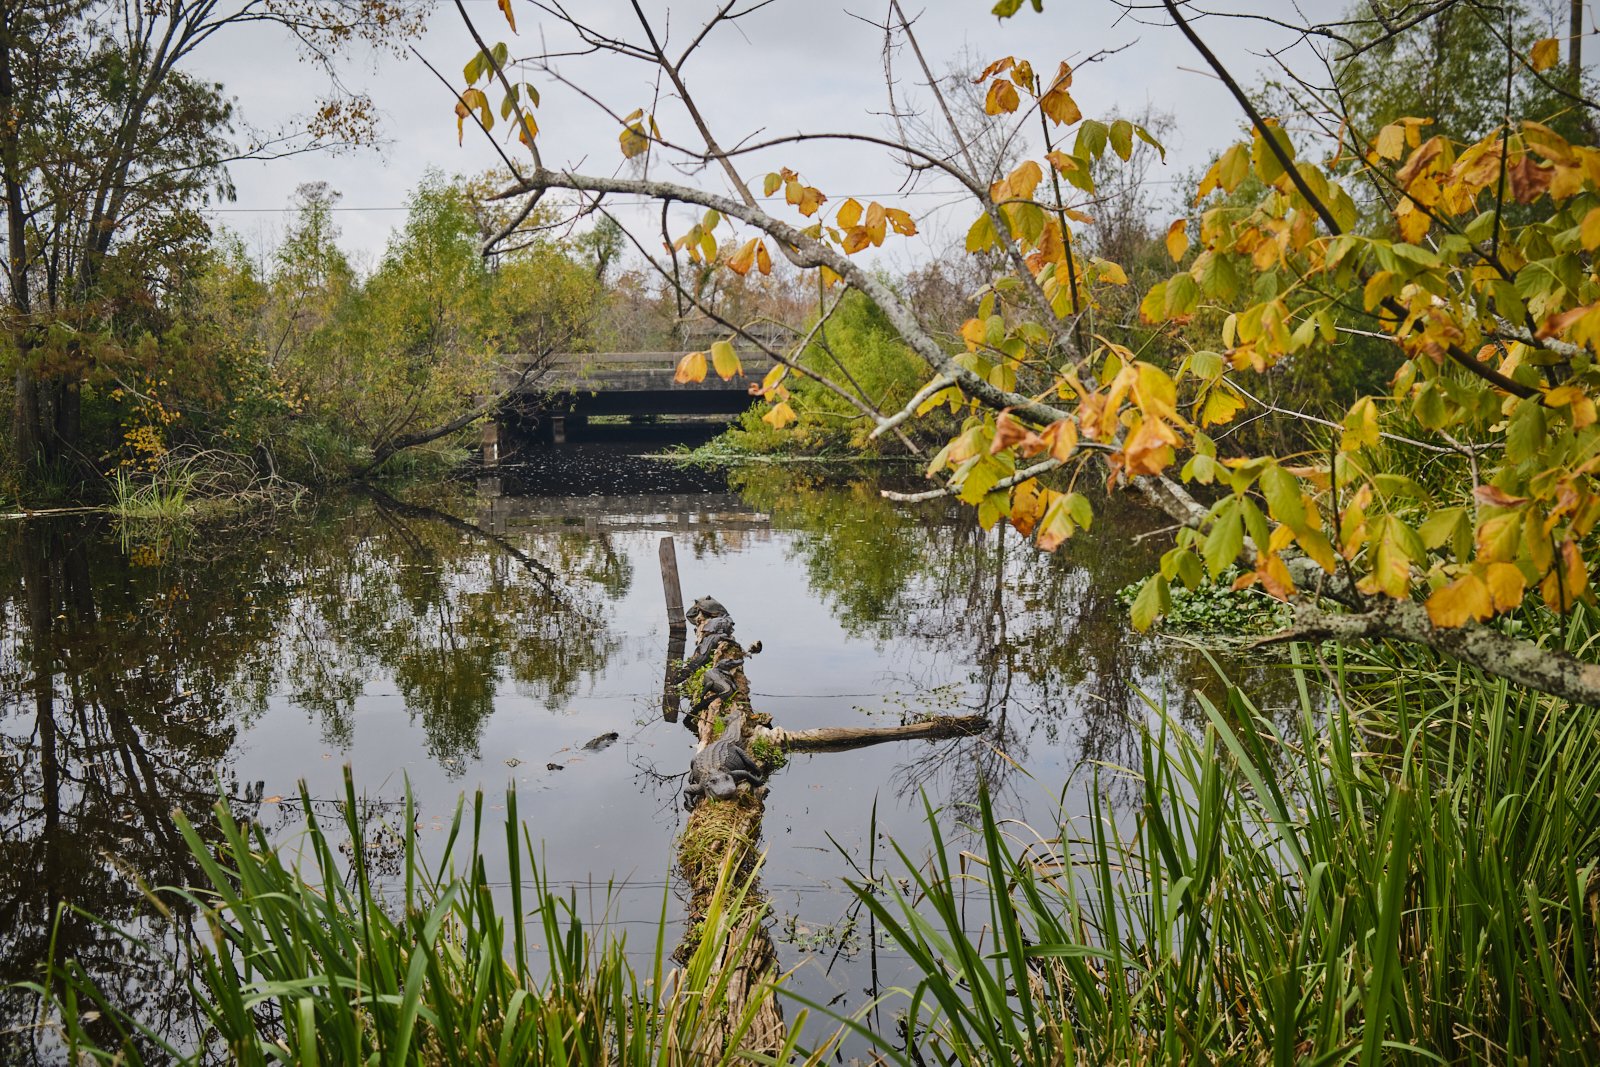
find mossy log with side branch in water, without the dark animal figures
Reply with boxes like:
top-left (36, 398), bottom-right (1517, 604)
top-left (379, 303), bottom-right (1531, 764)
top-left (674, 601), bottom-right (989, 1059)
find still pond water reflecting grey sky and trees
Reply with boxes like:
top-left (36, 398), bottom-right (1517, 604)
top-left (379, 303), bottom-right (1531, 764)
top-left (0, 431), bottom-right (1260, 1062)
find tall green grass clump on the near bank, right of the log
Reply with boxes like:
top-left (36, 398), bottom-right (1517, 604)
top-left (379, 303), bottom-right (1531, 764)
top-left (812, 646), bottom-right (1600, 1067)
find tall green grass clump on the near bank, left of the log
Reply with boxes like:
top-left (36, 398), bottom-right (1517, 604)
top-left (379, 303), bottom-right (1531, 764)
top-left (25, 776), bottom-right (803, 1067)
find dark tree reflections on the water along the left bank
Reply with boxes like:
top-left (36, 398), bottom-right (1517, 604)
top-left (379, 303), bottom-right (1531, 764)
top-left (0, 498), bottom-right (627, 1064)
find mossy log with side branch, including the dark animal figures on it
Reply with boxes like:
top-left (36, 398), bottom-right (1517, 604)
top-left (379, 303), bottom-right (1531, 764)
top-left (674, 597), bottom-right (989, 1059)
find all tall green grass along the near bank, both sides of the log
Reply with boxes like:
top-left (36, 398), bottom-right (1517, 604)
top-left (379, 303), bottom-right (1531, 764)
top-left (38, 630), bottom-right (1600, 1067)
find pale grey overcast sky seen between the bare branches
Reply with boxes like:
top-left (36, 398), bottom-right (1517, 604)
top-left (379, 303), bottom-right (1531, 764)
top-left (175, 0), bottom-right (1452, 264)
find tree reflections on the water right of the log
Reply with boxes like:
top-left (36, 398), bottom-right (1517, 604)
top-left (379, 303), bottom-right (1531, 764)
top-left (731, 467), bottom-right (1274, 805)
